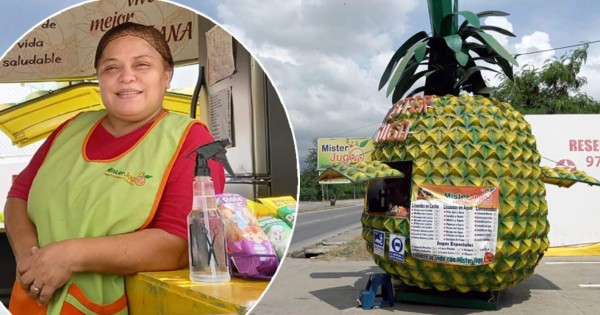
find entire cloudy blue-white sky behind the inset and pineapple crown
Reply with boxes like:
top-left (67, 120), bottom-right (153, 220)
top-left (0, 0), bottom-right (600, 168)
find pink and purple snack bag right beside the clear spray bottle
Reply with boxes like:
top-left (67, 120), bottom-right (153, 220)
top-left (217, 194), bottom-right (279, 278)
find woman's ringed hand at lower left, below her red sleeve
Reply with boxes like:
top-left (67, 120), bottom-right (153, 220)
top-left (17, 242), bottom-right (73, 305)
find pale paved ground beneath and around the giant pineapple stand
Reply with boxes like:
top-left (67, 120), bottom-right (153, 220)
top-left (252, 256), bottom-right (600, 315)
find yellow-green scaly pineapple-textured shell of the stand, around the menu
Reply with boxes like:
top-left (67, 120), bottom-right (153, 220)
top-left (361, 94), bottom-right (549, 292)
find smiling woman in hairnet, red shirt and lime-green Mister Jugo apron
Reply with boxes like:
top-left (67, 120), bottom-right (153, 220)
top-left (6, 23), bottom-right (224, 314)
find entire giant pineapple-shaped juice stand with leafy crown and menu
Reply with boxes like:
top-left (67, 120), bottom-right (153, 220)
top-left (319, 0), bottom-right (600, 309)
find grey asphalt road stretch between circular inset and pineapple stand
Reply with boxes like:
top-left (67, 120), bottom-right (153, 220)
top-left (288, 205), bottom-right (363, 253)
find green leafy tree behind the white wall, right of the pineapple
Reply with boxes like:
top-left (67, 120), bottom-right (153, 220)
top-left (492, 43), bottom-right (600, 114)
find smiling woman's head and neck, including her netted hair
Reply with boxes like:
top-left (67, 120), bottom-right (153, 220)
top-left (94, 23), bottom-right (173, 136)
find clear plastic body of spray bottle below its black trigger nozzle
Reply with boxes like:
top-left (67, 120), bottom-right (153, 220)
top-left (187, 176), bottom-right (231, 283)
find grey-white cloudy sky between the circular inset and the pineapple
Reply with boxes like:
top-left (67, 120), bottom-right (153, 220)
top-left (217, 0), bottom-right (417, 164)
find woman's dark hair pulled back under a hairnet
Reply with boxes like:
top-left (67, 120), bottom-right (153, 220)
top-left (94, 22), bottom-right (175, 69)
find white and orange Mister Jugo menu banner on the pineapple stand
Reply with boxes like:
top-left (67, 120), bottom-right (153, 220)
top-left (410, 185), bottom-right (500, 266)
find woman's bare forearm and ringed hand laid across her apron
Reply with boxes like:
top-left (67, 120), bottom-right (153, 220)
top-left (17, 229), bottom-right (187, 304)
